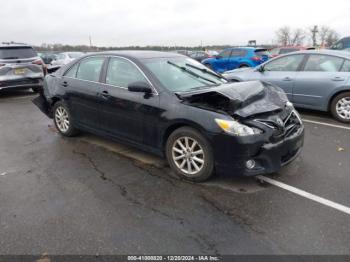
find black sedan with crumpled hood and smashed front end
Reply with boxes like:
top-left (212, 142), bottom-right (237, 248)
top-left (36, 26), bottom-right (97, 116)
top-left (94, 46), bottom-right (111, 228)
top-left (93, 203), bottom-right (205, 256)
top-left (34, 51), bottom-right (304, 181)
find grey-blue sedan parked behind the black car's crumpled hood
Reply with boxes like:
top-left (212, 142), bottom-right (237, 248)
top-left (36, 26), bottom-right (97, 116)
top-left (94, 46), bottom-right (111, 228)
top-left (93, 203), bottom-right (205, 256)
top-left (223, 50), bottom-right (350, 123)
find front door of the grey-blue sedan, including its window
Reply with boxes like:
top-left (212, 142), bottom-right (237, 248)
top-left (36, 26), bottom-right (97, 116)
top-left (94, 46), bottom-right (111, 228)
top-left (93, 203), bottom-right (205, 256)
top-left (259, 54), bottom-right (305, 101)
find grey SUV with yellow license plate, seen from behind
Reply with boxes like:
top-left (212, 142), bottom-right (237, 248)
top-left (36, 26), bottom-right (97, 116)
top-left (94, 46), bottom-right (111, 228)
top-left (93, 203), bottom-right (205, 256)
top-left (0, 43), bottom-right (45, 92)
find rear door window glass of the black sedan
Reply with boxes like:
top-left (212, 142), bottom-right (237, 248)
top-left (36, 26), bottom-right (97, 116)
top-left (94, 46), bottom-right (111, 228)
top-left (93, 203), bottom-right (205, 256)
top-left (77, 57), bottom-right (105, 82)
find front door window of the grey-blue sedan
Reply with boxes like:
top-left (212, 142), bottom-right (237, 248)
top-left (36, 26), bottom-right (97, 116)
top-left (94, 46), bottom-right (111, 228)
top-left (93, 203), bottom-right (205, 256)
top-left (264, 55), bottom-right (304, 72)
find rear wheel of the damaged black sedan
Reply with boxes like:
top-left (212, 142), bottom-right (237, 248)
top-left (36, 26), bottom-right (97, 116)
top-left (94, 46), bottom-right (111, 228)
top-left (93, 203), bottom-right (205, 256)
top-left (53, 101), bottom-right (78, 137)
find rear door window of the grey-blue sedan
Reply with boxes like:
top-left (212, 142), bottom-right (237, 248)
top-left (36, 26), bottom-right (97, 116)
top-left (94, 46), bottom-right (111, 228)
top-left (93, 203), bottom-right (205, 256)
top-left (304, 55), bottom-right (344, 72)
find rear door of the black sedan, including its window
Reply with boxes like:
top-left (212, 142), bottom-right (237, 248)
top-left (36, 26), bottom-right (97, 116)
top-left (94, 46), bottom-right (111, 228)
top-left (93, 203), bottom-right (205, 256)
top-left (60, 56), bottom-right (106, 129)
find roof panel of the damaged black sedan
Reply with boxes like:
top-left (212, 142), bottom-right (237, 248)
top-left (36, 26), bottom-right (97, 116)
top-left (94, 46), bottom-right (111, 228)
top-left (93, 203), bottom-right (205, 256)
top-left (89, 50), bottom-right (185, 59)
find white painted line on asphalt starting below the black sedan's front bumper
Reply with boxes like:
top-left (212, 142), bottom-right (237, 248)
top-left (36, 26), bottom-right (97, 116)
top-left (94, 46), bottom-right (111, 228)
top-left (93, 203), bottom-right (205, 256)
top-left (257, 176), bottom-right (350, 215)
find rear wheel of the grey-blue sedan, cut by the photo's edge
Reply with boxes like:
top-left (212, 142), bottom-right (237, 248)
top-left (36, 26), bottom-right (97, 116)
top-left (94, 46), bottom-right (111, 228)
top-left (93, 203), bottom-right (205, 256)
top-left (330, 92), bottom-right (350, 123)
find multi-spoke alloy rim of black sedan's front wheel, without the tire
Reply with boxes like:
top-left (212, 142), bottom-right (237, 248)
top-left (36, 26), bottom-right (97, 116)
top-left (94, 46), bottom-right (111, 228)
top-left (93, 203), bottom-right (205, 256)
top-left (172, 136), bottom-right (205, 177)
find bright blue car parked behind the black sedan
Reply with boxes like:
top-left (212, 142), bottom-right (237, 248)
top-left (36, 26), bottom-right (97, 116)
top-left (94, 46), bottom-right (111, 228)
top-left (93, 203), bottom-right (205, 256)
top-left (202, 47), bottom-right (270, 73)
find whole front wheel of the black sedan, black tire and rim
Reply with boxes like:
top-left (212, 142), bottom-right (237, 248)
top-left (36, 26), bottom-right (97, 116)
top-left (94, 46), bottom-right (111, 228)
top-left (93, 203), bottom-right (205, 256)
top-left (166, 127), bottom-right (214, 182)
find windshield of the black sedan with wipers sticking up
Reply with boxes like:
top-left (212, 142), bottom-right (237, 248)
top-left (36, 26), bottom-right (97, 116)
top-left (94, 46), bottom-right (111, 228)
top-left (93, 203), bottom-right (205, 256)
top-left (142, 57), bottom-right (227, 92)
